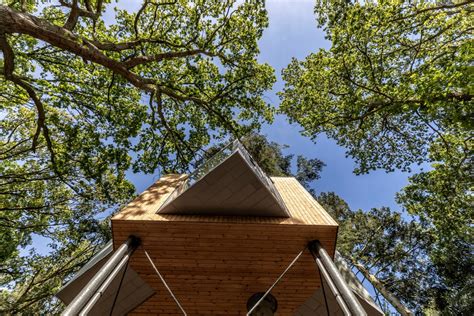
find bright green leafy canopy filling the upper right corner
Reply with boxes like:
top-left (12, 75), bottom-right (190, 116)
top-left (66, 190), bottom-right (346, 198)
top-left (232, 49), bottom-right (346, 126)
top-left (281, 0), bottom-right (473, 173)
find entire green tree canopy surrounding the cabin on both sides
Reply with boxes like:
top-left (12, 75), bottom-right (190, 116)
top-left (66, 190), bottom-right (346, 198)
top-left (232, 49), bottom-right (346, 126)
top-left (0, 0), bottom-right (474, 315)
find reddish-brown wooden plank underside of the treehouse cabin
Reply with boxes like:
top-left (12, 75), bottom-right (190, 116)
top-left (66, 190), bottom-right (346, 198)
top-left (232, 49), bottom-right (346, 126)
top-left (113, 221), bottom-right (336, 315)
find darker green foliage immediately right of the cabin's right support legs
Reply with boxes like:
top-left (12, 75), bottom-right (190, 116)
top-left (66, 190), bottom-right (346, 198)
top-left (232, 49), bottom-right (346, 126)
top-left (317, 192), bottom-right (439, 311)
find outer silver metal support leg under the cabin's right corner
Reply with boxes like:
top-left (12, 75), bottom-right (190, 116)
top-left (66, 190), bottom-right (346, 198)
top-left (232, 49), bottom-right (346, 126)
top-left (309, 240), bottom-right (367, 316)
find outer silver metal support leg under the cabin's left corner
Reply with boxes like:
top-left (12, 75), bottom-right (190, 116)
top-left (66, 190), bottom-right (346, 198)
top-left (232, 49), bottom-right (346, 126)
top-left (62, 236), bottom-right (140, 316)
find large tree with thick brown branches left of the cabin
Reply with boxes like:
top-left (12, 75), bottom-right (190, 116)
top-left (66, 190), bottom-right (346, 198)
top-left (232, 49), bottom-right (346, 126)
top-left (0, 0), bottom-right (274, 314)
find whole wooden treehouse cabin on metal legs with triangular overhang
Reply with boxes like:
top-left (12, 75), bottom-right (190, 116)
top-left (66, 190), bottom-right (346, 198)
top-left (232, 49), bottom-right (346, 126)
top-left (57, 141), bottom-right (382, 315)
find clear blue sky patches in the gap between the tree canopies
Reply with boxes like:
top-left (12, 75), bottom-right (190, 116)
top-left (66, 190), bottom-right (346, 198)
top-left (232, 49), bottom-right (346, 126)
top-left (129, 0), bottom-right (418, 210)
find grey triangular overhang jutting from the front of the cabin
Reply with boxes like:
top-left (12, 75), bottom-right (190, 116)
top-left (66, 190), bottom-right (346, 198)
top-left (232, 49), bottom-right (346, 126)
top-left (158, 141), bottom-right (289, 217)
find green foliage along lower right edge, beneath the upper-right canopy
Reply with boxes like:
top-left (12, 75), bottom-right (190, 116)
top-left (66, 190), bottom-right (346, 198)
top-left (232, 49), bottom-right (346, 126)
top-left (397, 134), bottom-right (474, 315)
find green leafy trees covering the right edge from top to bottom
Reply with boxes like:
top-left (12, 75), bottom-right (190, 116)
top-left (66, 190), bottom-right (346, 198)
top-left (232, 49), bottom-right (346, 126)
top-left (281, 0), bottom-right (474, 314)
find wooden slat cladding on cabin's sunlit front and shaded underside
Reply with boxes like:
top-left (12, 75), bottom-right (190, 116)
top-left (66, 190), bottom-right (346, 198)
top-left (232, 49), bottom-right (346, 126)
top-left (112, 175), bottom-right (337, 315)
